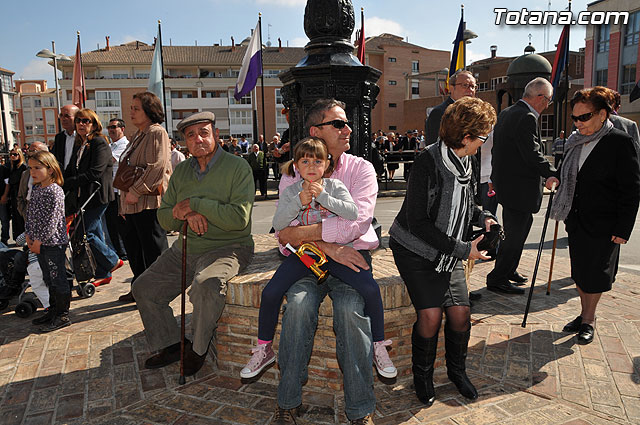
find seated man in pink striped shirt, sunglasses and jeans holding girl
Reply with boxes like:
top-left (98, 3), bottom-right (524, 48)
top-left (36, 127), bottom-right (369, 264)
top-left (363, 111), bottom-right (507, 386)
top-left (272, 99), bottom-right (378, 424)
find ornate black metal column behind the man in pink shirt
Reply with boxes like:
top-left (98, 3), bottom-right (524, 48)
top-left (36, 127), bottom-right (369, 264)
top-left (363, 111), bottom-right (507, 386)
top-left (279, 0), bottom-right (381, 159)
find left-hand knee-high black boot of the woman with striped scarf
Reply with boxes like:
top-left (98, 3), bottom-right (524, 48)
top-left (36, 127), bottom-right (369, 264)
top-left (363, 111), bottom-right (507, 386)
top-left (411, 324), bottom-right (438, 406)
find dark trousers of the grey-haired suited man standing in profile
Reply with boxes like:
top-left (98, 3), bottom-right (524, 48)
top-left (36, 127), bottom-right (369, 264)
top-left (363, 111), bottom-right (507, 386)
top-left (487, 205), bottom-right (533, 286)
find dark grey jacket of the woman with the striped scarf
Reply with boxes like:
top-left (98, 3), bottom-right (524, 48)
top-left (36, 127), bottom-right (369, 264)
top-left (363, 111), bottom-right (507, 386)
top-left (389, 142), bottom-right (495, 261)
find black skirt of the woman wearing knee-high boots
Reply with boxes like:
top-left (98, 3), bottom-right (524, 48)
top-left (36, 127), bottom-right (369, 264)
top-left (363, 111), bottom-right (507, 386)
top-left (389, 238), bottom-right (469, 310)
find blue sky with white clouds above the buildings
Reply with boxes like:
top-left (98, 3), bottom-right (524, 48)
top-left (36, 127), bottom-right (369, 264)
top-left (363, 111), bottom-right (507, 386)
top-left (0, 0), bottom-right (592, 87)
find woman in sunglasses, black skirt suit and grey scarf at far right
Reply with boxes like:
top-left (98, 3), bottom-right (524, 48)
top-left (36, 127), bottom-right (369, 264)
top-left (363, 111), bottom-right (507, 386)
top-left (551, 87), bottom-right (640, 344)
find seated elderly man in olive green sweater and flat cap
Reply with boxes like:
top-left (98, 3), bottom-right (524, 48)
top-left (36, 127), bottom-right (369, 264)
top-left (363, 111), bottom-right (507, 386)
top-left (133, 112), bottom-right (255, 376)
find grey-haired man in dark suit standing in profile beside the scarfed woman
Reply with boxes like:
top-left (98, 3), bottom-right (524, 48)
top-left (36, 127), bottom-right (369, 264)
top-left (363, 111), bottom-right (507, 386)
top-left (487, 78), bottom-right (559, 294)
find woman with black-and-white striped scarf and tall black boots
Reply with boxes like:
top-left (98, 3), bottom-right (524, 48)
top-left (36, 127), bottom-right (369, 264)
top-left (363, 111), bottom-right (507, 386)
top-left (389, 97), bottom-right (497, 406)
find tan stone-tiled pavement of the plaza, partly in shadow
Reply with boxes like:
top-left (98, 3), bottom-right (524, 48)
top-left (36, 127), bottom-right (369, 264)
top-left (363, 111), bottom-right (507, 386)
top-left (0, 235), bottom-right (640, 425)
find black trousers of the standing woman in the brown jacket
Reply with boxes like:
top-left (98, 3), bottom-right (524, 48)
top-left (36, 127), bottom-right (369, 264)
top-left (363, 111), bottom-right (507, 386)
top-left (124, 209), bottom-right (169, 283)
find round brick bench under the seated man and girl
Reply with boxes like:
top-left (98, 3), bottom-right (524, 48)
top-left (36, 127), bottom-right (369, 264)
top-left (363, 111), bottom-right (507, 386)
top-left (210, 235), bottom-right (444, 391)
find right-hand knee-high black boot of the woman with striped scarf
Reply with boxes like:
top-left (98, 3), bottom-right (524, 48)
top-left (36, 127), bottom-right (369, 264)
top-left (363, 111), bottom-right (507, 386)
top-left (444, 325), bottom-right (478, 400)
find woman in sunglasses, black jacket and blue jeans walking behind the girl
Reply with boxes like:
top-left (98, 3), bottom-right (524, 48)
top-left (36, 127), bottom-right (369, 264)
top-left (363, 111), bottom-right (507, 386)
top-left (63, 109), bottom-right (123, 286)
